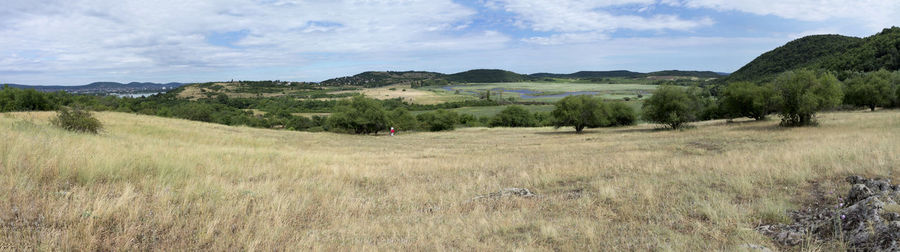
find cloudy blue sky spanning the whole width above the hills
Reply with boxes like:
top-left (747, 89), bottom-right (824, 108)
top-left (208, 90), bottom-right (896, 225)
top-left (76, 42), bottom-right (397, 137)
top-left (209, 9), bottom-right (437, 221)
top-left (0, 0), bottom-right (900, 85)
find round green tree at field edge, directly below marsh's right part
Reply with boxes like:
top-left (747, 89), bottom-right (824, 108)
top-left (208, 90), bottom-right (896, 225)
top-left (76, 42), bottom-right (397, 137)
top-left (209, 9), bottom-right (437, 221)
top-left (550, 95), bottom-right (611, 134)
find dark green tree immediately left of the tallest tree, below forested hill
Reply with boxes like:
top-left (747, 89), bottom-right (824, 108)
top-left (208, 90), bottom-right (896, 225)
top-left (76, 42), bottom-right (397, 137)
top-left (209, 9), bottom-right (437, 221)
top-left (722, 81), bottom-right (778, 120)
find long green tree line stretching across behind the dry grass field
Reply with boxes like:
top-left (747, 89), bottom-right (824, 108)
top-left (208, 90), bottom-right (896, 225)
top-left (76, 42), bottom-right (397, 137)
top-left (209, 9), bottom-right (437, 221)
top-left (0, 67), bottom-right (900, 134)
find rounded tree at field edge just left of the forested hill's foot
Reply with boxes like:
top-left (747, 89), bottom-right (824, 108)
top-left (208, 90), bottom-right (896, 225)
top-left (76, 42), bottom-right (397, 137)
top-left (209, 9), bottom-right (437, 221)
top-left (642, 85), bottom-right (703, 129)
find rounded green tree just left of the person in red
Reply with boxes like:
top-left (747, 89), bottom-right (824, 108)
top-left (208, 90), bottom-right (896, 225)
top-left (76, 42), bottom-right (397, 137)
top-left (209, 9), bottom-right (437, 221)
top-left (327, 96), bottom-right (388, 134)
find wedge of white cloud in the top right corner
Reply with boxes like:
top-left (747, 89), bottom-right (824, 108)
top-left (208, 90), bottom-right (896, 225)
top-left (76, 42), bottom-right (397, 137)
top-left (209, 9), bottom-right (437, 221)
top-left (676, 0), bottom-right (900, 29)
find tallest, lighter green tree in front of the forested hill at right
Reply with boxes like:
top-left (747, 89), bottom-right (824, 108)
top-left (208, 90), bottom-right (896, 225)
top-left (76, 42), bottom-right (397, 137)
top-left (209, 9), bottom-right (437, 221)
top-left (774, 70), bottom-right (844, 126)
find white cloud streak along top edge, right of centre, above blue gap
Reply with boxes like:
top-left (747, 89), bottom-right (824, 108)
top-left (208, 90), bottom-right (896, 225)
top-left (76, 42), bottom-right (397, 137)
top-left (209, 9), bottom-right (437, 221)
top-left (489, 0), bottom-right (713, 33)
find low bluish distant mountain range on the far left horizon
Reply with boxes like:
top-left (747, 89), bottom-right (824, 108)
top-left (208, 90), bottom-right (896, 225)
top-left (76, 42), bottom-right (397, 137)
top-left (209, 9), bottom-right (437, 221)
top-left (4, 82), bottom-right (185, 94)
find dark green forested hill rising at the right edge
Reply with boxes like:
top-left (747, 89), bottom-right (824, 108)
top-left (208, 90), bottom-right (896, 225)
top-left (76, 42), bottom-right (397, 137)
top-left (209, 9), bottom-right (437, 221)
top-left (725, 27), bottom-right (900, 82)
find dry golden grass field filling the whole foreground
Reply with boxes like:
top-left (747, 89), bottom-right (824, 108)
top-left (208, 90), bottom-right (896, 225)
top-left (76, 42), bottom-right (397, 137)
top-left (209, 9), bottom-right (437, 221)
top-left (0, 111), bottom-right (900, 251)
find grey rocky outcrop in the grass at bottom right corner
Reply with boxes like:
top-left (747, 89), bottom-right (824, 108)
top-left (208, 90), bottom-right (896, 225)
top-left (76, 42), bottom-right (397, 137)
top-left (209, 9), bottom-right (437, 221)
top-left (756, 176), bottom-right (900, 251)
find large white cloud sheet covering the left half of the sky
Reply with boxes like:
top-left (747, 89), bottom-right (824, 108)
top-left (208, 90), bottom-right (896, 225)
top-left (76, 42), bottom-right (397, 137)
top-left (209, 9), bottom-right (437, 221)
top-left (0, 0), bottom-right (510, 83)
